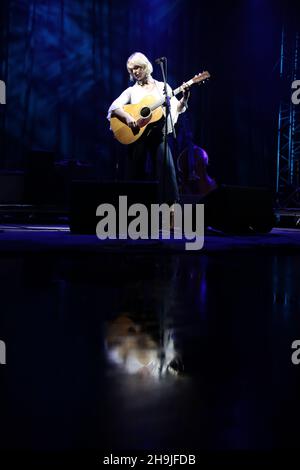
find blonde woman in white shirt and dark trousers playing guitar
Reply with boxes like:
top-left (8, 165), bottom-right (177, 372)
top-left (107, 52), bottom-right (189, 209)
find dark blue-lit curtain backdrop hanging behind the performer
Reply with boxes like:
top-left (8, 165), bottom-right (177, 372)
top-left (0, 0), bottom-right (298, 186)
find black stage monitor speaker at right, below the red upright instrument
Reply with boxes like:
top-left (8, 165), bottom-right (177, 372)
top-left (200, 185), bottom-right (275, 234)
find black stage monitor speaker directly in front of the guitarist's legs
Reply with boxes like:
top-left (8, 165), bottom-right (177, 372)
top-left (69, 181), bottom-right (158, 235)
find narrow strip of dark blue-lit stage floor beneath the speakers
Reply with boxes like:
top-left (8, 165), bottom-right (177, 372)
top-left (0, 225), bottom-right (300, 254)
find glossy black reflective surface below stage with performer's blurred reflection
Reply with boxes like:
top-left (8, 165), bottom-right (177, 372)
top-left (0, 248), bottom-right (300, 460)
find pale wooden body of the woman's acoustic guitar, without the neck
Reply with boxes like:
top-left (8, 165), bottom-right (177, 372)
top-left (110, 95), bottom-right (163, 145)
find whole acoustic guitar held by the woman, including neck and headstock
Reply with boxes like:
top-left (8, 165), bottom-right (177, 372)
top-left (110, 72), bottom-right (210, 145)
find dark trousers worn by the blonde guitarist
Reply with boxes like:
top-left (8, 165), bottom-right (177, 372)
top-left (126, 122), bottom-right (179, 204)
